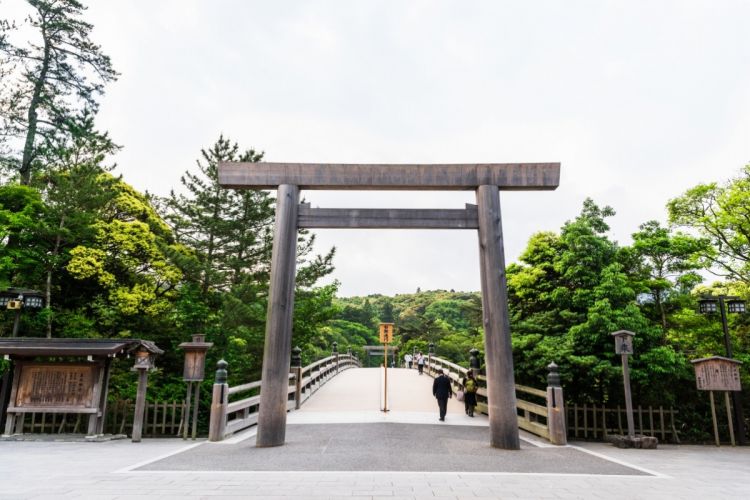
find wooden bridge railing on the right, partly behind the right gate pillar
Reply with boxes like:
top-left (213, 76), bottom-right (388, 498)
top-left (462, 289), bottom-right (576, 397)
top-left (425, 356), bottom-right (567, 445)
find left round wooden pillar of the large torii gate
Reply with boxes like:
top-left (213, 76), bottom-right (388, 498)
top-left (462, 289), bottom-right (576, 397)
top-left (255, 184), bottom-right (299, 447)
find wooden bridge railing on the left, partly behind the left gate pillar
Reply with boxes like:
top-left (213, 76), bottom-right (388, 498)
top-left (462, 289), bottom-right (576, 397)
top-left (208, 348), bottom-right (361, 441)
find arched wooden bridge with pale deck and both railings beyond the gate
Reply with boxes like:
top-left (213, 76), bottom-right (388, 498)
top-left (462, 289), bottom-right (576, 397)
top-left (209, 354), bottom-right (566, 445)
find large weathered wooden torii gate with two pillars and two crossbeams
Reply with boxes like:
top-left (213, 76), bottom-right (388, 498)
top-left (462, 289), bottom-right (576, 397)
top-left (219, 162), bottom-right (560, 450)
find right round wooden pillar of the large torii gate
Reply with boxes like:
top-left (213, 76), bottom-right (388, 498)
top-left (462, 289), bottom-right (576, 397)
top-left (477, 185), bottom-right (521, 450)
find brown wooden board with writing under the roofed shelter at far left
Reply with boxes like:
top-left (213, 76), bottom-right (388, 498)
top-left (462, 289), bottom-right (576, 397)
top-left (9, 363), bottom-right (101, 413)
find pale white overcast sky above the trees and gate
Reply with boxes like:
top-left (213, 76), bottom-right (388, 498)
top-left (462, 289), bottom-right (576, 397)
top-left (5, 0), bottom-right (750, 296)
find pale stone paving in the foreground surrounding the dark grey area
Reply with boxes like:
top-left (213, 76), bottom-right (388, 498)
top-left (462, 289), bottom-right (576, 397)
top-left (0, 439), bottom-right (750, 500)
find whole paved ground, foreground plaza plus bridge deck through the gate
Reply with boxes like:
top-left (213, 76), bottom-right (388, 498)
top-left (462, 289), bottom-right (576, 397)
top-left (0, 370), bottom-right (750, 500)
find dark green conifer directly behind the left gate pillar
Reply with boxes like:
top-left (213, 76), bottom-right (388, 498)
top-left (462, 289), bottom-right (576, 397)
top-left (164, 136), bottom-right (335, 371)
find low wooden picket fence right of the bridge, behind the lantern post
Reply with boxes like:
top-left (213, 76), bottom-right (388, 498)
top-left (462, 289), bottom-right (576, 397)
top-left (566, 404), bottom-right (680, 444)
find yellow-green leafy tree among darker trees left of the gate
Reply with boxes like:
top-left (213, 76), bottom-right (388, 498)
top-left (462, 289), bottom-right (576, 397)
top-left (66, 174), bottom-right (186, 336)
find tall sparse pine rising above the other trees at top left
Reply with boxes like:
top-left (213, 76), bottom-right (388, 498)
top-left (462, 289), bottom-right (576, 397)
top-left (0, 0), bottom-right (117, 184)
